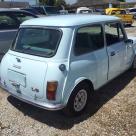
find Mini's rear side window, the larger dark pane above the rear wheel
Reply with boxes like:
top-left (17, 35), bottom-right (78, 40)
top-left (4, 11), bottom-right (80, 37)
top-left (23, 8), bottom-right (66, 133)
top-left (74, 25), bottom-right (104, 55)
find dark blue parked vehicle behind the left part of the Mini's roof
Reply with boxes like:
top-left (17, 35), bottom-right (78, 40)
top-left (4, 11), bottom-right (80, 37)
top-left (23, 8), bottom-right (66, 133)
top-left (31, 6), bottom-right (61, 15)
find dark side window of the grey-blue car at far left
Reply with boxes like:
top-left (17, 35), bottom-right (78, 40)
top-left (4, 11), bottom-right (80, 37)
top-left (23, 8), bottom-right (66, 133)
top-left (0, 14), bottom-right (17, 30)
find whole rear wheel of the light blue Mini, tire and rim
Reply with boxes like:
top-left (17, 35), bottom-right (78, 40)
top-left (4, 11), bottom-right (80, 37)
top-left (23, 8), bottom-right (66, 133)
top-left (63, 83), bottom-right (90, 116)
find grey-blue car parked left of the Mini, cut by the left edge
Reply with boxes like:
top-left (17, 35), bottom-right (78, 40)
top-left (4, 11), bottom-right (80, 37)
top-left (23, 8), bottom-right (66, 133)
top-left (0, 9), bottom-right (37, 61)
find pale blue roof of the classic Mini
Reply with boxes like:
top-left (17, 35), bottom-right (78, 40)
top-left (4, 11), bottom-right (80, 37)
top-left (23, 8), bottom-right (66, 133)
top-left (21, 14), bottom-right (120, 27)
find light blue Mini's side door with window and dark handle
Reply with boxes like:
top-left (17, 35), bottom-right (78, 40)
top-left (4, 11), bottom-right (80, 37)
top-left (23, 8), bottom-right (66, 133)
top-left (105, 22), bottom-right (131, 80)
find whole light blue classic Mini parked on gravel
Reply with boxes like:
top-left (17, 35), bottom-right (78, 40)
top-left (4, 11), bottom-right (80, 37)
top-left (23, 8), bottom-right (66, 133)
top-left (1, 14), bottom-right (136, 115)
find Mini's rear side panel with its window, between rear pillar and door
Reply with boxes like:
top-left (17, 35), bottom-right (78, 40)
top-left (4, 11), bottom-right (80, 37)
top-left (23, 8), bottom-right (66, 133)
top-left (69, 24), bottom-right (108, 89)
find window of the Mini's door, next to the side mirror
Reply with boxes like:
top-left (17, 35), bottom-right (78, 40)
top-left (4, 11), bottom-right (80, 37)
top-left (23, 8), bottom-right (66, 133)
top-left (105, 23), bottom-right (125, 46)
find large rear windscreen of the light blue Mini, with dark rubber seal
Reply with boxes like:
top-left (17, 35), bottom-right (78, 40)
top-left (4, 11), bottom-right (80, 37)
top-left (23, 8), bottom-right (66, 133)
top-left (12, 28), bottom-right (61, 57)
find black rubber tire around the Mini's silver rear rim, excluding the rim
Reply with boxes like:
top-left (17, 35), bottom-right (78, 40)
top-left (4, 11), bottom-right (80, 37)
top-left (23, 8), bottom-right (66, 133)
top-left (63, 83), bottom-right (91, 116)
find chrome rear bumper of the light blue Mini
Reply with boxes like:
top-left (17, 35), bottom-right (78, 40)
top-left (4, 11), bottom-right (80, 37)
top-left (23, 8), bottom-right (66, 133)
top-left (0, 84), bottom-right (65, 111)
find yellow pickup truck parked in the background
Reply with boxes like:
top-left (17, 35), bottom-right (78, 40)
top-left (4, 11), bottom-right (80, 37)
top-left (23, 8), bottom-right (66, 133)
top-left (105, 8), bottom-right (134, 26)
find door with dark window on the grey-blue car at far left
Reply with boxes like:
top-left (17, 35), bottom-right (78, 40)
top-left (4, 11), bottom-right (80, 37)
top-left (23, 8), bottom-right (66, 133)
top-left (0, 12), bottom-right (19, 61)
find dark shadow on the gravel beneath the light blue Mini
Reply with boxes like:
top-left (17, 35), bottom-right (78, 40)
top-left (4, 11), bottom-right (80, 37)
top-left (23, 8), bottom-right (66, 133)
top-left (8, 70), bottom-right (136, 130)
